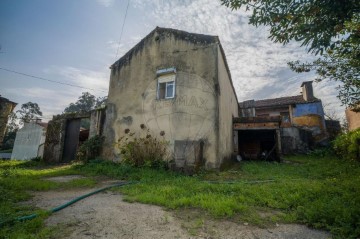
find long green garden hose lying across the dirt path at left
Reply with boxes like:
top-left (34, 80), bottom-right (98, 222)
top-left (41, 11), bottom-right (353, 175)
top-left (0, 182), bottom-right (136, 227)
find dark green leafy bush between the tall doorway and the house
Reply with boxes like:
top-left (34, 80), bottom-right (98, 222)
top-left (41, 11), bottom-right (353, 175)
top-left (77, 135), bottom-right (104, 162)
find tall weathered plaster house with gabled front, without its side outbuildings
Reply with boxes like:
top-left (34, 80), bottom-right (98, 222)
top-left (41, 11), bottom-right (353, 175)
top-left (102, 27), bottom-right (238, 169)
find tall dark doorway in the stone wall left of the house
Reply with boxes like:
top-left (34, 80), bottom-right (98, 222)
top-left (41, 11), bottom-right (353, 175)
top-left (62, 119), bottom-right (81, 162)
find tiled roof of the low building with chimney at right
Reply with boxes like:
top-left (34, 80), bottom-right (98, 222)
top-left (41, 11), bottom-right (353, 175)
top-left (239, 95), bottom-right (320, 108)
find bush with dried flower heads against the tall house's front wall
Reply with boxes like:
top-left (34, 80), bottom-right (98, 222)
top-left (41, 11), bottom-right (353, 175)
top-left (117, 125), bottom-right (169, 168)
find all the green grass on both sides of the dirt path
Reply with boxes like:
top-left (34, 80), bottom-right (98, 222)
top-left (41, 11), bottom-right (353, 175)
top-left (0, 156), bottom-right (360, 238)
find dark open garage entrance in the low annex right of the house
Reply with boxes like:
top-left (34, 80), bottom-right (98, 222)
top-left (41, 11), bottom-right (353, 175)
top-left (238, 129), bottom-right (279, 161)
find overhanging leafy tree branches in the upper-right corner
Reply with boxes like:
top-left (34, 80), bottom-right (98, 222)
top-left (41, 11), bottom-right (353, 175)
top-left (221, 0), bottom-right (360, 110)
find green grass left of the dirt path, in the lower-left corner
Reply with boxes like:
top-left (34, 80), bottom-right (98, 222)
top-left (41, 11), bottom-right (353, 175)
top-left (0, 160), bottom-right (95, 238)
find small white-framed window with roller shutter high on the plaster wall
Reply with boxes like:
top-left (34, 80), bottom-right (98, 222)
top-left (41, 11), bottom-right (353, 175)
top-left (157, 68), bottom-right (176, 100)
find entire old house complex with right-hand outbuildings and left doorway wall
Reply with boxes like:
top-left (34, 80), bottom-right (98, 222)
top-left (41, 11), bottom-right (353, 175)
top-left (44, 27), bottom-right (334, 166)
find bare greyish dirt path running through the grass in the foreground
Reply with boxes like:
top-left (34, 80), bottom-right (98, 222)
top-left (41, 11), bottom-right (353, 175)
top-left (29, 176), bottom-right (330, 239)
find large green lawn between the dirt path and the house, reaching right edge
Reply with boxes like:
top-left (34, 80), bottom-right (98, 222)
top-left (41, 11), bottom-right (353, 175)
top-left (75, 156), bottom-right (360, 238)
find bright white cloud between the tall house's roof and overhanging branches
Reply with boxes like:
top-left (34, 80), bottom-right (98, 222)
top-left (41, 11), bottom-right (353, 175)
top-left (132, 0), bottom-right (344, 118)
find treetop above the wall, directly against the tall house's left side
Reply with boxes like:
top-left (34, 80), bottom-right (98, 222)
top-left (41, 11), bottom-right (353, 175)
top-left (64, 92), bottom-right (107, 113)
